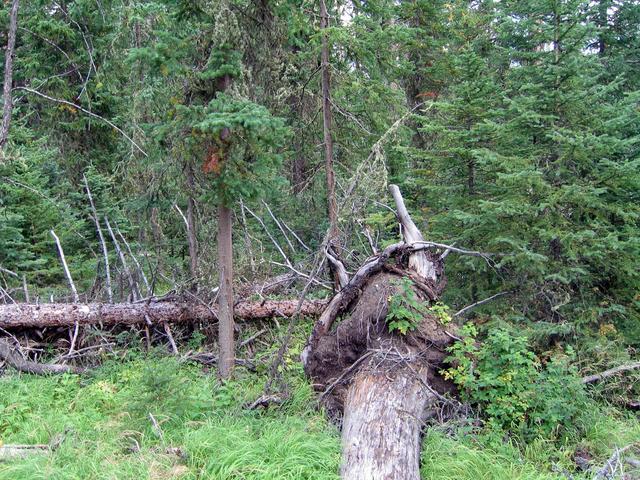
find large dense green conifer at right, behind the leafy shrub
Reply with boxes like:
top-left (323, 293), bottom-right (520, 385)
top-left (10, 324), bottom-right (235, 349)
top-left (412, 0), bottom-right (640, 342)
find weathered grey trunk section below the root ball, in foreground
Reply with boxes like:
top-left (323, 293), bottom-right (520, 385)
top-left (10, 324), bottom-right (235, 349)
top-left (341, 367), bottom-right (435, 480)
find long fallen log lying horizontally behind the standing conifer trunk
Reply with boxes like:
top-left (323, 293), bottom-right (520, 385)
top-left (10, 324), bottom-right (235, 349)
top-left (0, 300), bottom-right (326, 329)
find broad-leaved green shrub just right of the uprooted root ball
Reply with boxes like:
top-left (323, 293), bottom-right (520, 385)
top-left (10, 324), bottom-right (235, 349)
top-left (444, 325), bottom-right (586, 437)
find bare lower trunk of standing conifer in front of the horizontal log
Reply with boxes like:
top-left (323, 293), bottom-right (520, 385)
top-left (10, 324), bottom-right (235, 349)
top-left (218, 203), bottom-right (235, 379)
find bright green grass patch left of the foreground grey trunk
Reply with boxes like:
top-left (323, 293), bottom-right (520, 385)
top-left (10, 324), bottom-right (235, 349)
top-left (0, 353), bottom-right (340, 480)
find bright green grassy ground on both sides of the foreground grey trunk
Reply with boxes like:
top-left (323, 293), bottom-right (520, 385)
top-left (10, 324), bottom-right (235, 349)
top-left (0, 324), bottom-right (640, 480)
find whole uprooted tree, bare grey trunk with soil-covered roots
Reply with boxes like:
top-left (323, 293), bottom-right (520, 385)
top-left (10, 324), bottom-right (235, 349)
top-left (302, 186), bottom-right (455, 480)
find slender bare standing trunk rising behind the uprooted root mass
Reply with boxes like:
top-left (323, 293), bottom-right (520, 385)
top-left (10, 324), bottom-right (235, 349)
top-left (320, 0), bottom-right (338, 243)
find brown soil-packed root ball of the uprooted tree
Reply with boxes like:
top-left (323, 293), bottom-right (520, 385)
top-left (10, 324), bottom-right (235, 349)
top-left (305, 268), bottom-right (456, 418)
